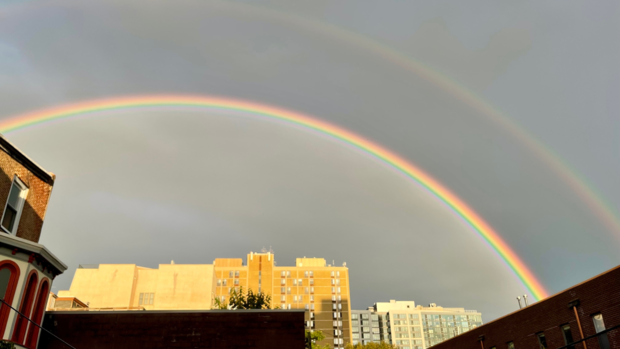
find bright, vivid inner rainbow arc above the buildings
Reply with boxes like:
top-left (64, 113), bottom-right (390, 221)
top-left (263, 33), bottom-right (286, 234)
top-left (0, 95), bottom-right (548, 300)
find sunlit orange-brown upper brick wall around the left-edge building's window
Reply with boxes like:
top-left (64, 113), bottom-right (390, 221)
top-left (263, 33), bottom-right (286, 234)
top-left (0, 151), bottom-right (52, 242)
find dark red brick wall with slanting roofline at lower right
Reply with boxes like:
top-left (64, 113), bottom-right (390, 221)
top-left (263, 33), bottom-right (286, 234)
top-left (432, 267), bottom-right (620, 349)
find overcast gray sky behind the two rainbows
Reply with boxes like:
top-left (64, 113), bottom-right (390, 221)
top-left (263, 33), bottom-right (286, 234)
top-left (0, 0), bottom-right (620, 321)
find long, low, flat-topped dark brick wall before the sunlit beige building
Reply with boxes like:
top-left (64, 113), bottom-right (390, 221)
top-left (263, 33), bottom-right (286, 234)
top-left (39, 310), bottom-right (304, 349)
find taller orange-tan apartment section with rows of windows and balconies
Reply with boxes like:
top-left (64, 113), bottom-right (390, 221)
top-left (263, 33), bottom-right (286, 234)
top-left (213, 252), bottom-right (351, 348)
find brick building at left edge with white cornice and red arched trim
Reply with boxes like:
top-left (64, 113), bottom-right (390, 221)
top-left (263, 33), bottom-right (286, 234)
top-left (0, 136), bottom-right (67, 348)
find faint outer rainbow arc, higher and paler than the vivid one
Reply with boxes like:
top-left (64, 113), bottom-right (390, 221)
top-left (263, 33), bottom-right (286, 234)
top-left (0, 0), bottom-right (620, 234)
